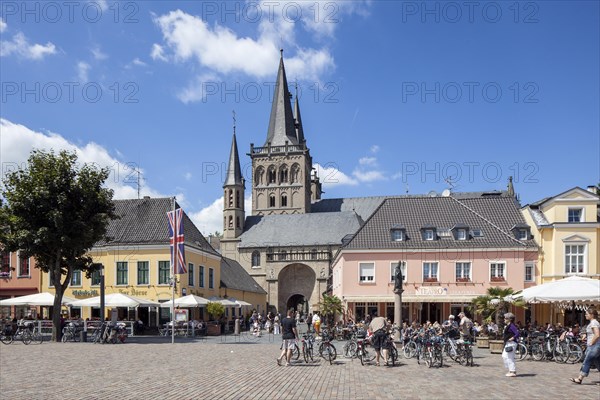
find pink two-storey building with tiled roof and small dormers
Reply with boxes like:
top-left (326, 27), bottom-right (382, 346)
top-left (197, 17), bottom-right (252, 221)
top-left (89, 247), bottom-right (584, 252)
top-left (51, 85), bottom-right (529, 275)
top-left (332, 192), bottom-right (538, 322)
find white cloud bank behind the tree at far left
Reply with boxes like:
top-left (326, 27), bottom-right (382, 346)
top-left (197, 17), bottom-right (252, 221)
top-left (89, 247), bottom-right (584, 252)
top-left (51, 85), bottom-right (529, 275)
top-left (0, 118), bottom-right (165, 199)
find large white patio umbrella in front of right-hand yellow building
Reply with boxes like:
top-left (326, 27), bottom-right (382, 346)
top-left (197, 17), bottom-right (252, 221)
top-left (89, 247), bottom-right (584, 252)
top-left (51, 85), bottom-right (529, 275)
top-left (512, 276), bottom-right (600, 303)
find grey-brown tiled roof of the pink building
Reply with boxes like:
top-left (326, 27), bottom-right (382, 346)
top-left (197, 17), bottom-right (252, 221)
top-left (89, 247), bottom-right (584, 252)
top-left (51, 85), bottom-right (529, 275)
top-left (345, 192), bottom-right (537, 249)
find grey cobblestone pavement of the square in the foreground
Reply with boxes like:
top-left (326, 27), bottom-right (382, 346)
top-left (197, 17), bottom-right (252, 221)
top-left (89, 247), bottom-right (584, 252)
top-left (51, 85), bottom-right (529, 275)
top-left (0, 335), bottom-right (600, 400)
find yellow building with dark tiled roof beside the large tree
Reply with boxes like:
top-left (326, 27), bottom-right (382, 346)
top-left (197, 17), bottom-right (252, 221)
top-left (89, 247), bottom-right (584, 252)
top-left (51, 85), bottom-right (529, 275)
top-left (42, 197), bottom-right (266, 326)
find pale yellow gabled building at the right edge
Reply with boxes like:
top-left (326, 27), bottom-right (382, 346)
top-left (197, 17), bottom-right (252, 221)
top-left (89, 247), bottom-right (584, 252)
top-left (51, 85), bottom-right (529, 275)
top-left (522, 186), bottom-right (600, 323)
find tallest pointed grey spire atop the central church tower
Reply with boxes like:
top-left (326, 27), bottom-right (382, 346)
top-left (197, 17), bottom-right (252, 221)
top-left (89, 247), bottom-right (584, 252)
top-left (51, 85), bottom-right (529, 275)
top-left (265, 49), bottom-right (298, 146)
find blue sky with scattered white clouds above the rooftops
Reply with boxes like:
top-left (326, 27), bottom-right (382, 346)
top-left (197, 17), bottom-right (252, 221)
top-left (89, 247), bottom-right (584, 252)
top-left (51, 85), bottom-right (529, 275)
top-left (0, 0), bottom-right (600, 234)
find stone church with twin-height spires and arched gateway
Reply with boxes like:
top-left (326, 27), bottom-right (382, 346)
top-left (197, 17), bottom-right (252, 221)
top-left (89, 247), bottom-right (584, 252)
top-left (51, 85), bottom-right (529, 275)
top-left (221, 56), bottom-right (383, 313)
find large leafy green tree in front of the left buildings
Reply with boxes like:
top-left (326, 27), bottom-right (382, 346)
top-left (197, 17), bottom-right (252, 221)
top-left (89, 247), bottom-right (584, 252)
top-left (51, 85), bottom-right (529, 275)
top-left (0, 150), bottom-right (116, 341)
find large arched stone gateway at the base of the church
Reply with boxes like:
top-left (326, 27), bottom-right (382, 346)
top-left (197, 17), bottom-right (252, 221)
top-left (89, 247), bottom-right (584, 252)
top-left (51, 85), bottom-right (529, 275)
top-left (277, 263), bottom-right (317, 315)
